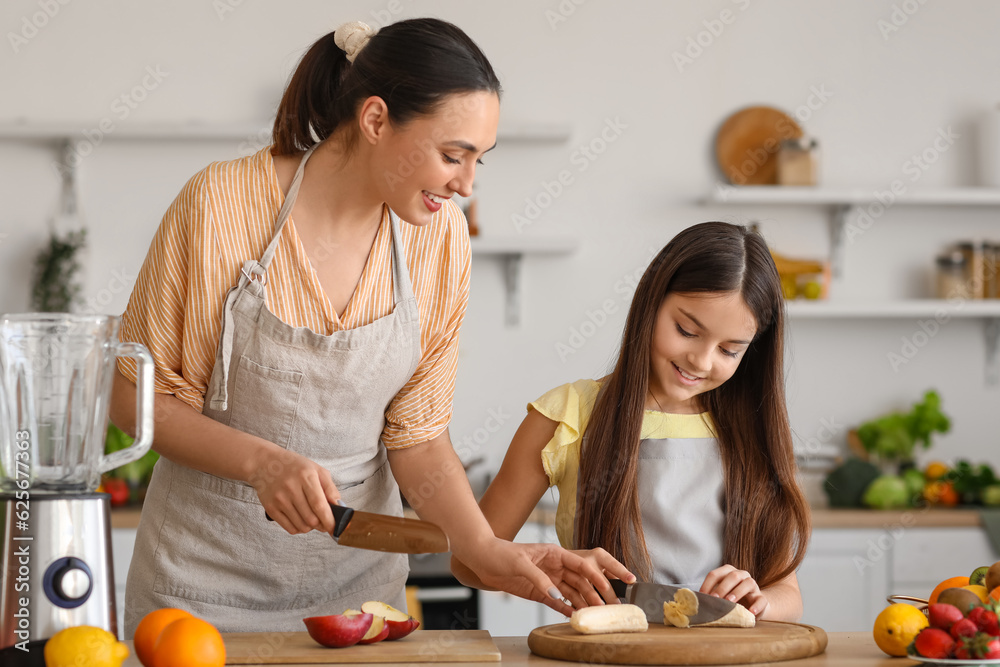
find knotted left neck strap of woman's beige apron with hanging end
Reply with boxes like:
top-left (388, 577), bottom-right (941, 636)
top-left (208, 144), bottom-right (319, 412)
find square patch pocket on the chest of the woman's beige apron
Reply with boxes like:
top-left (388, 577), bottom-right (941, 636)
top-left (229, 355), bottom-right (304, 449)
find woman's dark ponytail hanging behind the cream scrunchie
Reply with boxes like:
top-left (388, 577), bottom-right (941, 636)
top-left (272, 32), bottom-right (351, 155)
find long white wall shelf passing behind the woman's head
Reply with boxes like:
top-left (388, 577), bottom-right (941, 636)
top-left (0, 120), bottom-right (572, 143)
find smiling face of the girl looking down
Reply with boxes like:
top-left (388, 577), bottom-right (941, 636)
top-left (649, 292), bottom-right (757, 414)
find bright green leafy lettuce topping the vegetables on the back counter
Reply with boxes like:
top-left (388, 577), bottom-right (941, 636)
top-left (858, 391), bottom-right (951, 468)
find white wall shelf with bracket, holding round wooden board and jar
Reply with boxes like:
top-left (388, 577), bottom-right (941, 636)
top-left (704, 185), bottom-right (1000, 277)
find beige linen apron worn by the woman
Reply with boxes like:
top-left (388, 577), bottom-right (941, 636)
top-left (125, 147), bottom-right (420, 637)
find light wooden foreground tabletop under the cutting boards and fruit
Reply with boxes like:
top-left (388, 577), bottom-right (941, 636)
top-left (117, 632), bottom-right (892, 667)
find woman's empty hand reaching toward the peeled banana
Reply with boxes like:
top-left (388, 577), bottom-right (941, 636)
top-left (468, 538), bottom-right (635, 616)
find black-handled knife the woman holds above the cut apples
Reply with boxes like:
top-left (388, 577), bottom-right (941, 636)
top-left (264, 503), bottom-right (451, 554)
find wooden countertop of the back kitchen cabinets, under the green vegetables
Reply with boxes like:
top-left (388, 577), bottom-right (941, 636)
top-left (111, 507), bottom-right (982, 530)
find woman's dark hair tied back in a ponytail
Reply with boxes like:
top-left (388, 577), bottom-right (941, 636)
top-left (272, 19), bottom-right (501, 155)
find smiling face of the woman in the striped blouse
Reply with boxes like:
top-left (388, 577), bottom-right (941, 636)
top-left (373, 92), bottom-right (500, 225)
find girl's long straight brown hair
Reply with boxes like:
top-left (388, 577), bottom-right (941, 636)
top-left (576, 222), bottom-right (810, 588)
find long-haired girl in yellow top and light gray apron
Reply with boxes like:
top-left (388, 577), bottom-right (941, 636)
top-left (453, 222), bottom-right (810, 620)
